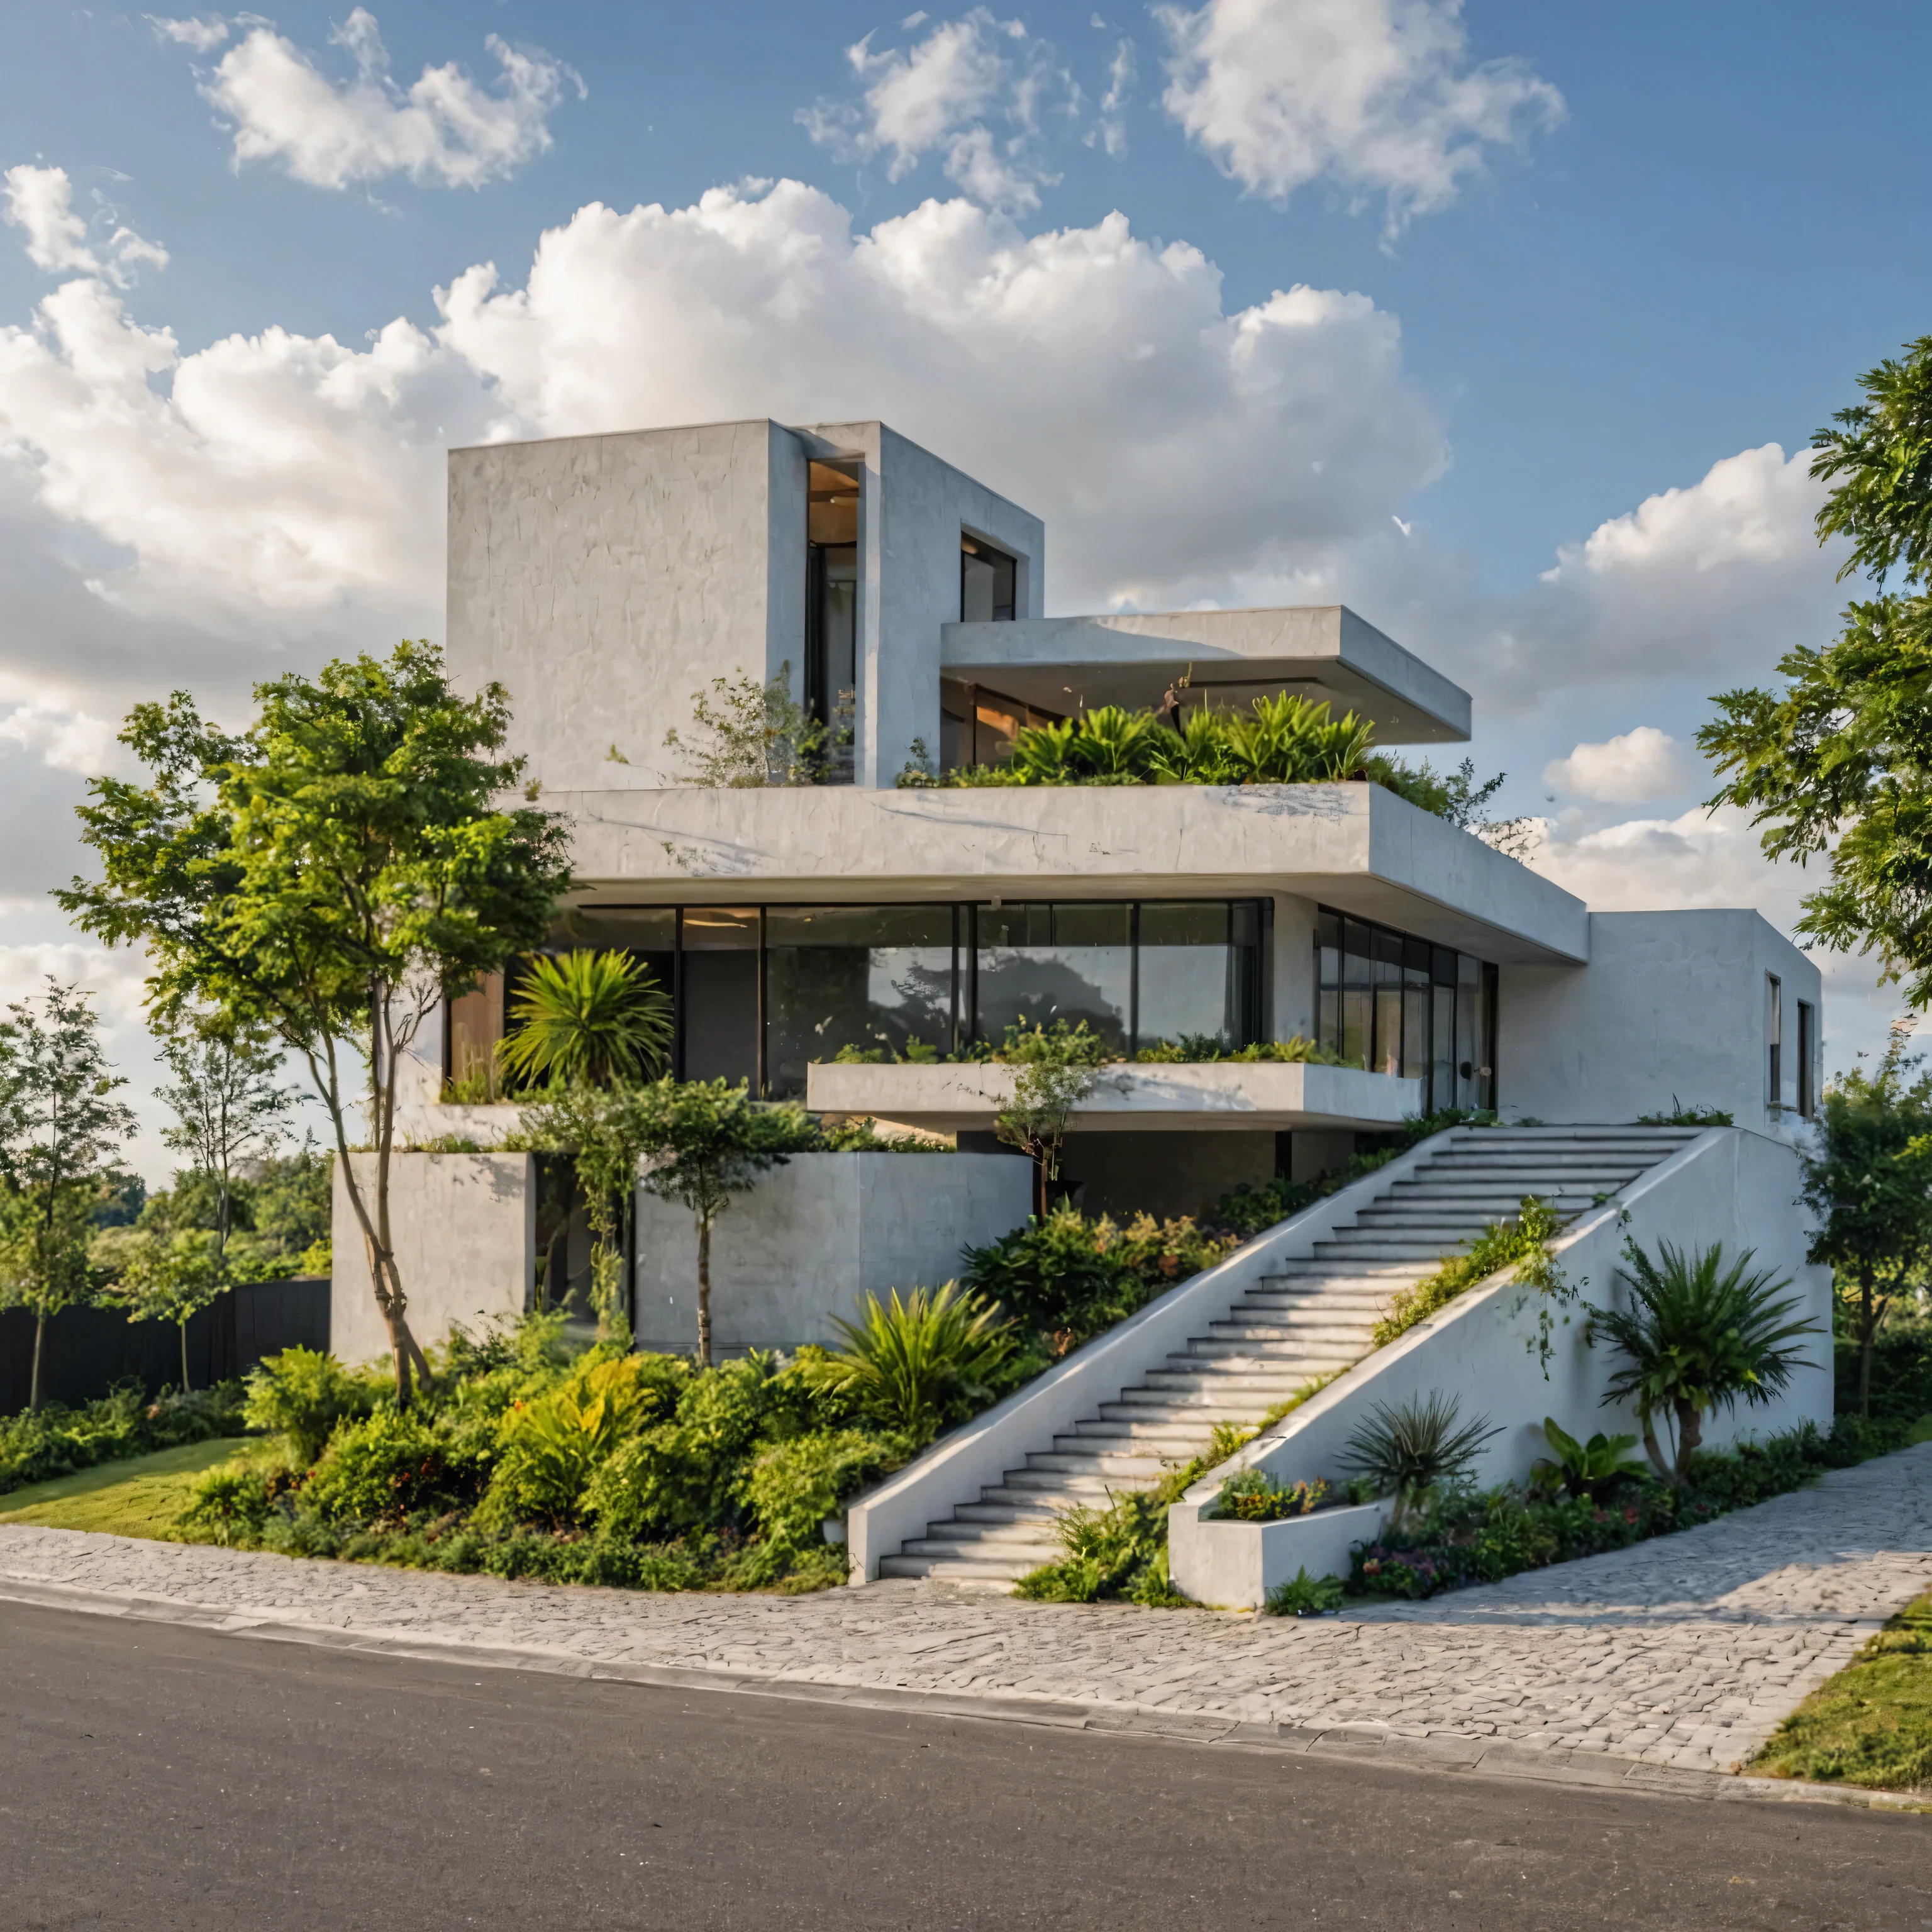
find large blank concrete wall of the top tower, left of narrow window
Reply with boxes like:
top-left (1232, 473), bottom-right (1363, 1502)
top-left (448, 419), bottom-right (803, 790)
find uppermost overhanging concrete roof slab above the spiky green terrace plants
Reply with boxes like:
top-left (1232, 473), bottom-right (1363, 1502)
top-left (939, 605), bottom-right (1470, 744)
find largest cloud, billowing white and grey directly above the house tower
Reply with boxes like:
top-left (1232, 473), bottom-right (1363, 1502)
top-left (438, 182), bottom-right (1443, 609)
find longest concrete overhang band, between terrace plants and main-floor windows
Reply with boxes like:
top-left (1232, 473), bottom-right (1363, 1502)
top-left (543, 782), bottom-right (1590, 966)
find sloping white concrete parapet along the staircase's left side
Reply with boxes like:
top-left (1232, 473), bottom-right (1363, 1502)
top-left (847, 1128), bottom-right (1470, 1582)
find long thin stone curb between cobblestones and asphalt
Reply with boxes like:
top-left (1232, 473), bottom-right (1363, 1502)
top-left (0, 1575), bottom-right (1932, 1813)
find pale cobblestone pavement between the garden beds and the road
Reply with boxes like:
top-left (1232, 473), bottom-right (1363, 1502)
top-left (0, 1443), bottom-right (1932, 1772)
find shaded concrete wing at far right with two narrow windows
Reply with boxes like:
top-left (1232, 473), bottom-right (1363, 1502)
top-left (1497, 910), bottom-right (1824, 1134)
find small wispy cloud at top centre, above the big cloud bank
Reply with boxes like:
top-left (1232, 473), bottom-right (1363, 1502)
top-left (796, 6), bottom-right (1082, 209)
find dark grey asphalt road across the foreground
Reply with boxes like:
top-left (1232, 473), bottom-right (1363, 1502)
top-left (0, 1606), bottom-right (1932, 1932)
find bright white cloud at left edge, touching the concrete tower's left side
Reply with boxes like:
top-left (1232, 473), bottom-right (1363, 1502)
top-left (0, 280), bottom-right (442, 630)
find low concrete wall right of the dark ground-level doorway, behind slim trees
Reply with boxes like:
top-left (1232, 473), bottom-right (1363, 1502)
top-left (636, 1153), bottom-right (1034, 1352)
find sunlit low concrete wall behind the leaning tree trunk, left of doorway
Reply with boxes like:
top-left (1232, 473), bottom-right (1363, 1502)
top-left (328, 1153), bottom-right (537, 1362)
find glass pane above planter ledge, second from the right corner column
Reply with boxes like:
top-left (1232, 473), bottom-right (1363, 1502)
top-left (974, 901), bottom-right (1134, 1051)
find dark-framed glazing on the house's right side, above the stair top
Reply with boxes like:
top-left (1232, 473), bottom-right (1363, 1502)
top-left (1316, 908), bottom-right (1496, 1109)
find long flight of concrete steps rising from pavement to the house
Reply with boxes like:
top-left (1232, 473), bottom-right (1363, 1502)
top-left (879, 1126), bottom-right (1698, 1588)
